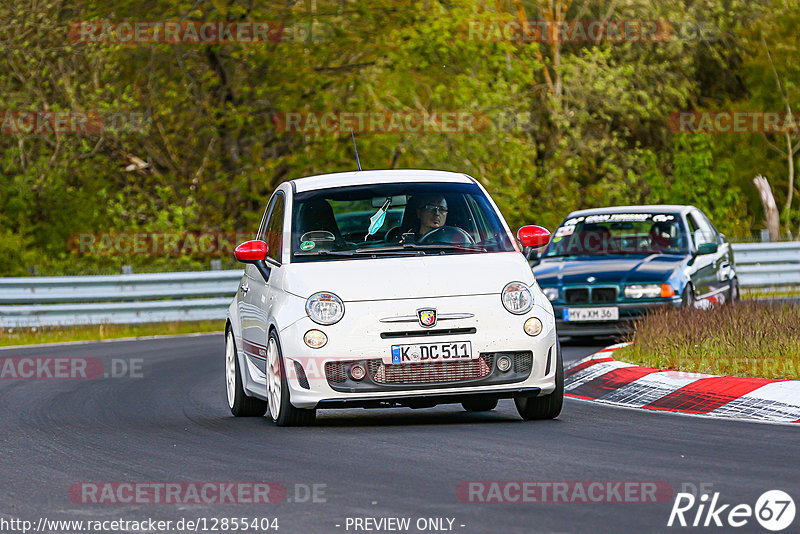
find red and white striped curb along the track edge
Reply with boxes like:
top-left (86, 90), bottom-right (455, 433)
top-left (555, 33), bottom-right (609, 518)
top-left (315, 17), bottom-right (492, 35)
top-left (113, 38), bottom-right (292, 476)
top-left (564, 343), bottom-right (800, 423)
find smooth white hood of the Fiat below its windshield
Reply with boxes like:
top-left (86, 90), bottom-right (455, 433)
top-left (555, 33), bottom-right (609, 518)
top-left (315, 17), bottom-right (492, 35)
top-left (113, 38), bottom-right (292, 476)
top-left (283, 252), bottom-right (533, 302)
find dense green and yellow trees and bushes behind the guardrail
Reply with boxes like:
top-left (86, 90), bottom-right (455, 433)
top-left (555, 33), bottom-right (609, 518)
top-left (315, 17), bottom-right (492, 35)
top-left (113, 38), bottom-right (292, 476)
top-left (0, 0), bottom-right (800, 275)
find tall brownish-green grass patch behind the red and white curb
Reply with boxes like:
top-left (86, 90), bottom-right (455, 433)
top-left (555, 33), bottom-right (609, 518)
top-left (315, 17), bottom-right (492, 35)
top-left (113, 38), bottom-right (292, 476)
top-left (614, 301), bottom-right (800, 380)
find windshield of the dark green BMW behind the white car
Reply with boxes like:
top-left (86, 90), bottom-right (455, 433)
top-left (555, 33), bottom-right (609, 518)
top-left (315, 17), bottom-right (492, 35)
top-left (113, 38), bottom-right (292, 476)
top-left (542, 213), bottom-right (688, 258)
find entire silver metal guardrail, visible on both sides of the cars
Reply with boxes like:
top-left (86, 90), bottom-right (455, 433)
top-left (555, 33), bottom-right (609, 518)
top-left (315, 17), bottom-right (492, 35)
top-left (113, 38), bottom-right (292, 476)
top-left (0, 242), bottom-right (800, 328)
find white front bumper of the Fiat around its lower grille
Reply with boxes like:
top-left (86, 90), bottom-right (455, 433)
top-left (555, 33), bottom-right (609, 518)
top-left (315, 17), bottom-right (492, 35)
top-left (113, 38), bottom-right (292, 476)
top-left (279, 291), bottom-right (557, 408)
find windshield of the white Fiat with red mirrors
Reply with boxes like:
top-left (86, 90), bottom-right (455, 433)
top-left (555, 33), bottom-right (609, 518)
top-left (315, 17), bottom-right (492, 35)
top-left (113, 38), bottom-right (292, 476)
top-left (292, 182), bottom-right (515, 261)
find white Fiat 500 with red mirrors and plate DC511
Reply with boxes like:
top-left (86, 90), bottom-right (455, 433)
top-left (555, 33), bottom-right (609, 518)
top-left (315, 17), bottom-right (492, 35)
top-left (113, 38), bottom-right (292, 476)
top-left (225, 170), bottom-right (564, 426)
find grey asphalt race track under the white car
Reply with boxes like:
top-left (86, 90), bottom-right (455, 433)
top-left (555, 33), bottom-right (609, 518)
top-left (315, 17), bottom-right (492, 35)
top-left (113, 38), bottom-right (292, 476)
top-left (0, 335), bottom-right (800, 533)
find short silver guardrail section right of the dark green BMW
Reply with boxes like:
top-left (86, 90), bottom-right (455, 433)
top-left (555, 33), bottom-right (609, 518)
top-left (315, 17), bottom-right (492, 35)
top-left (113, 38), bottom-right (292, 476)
top-left (731, 241), bottom-right (800, 288)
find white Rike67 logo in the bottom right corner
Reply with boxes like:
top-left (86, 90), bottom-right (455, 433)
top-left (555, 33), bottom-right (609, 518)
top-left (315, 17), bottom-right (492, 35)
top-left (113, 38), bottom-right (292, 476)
top-left (667, 490), bottom-right (796, 532)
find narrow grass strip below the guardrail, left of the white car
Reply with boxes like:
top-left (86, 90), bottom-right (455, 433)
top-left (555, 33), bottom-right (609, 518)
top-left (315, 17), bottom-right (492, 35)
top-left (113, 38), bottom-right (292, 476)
top-left (0, 321), bottom-right (225, 347)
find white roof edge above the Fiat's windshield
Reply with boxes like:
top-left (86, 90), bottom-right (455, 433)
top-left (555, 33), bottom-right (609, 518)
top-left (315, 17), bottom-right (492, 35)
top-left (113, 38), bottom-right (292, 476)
top-left (291, 169), bottom-right (473, 193)
